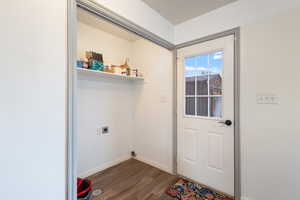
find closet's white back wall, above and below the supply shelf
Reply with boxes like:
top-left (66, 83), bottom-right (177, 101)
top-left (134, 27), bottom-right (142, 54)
top-left (77, 23), bottom-right (134, 176)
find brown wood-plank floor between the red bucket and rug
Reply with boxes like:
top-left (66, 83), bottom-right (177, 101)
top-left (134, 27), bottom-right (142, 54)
top-left (89, 159), bottom-right (178, 200)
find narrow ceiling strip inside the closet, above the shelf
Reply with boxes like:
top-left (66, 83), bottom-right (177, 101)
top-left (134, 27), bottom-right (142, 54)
top-left (77, 8), bottom-right (139, 41)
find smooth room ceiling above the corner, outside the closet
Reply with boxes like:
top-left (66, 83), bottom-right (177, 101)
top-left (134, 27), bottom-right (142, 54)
top-left (142, 0), bottom-right (237, 25)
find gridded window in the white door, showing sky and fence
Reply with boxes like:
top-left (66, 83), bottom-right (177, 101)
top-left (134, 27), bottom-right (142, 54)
top-left (184, 51), bottom-right (223, 118)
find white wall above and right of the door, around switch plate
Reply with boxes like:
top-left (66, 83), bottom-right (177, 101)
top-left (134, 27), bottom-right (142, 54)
top-left (176, 5), bottom-right (300, 200)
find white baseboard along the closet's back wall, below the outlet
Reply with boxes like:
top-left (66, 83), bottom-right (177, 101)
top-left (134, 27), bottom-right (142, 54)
top-left (79, 155), bottom-right (131, 178)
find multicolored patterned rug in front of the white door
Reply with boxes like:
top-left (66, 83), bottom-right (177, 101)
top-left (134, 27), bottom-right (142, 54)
top-left (166, 179), bottom-right (233, 200)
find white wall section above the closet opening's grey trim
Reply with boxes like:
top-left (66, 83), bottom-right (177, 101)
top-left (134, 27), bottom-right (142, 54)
top-left (95, 0), bottom-right (174, 42)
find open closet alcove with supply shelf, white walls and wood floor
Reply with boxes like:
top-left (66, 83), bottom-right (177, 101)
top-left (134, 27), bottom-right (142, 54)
top-left (73, 7), bottom-right (176, 199)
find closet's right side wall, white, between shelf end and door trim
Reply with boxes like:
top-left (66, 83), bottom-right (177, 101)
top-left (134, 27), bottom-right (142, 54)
top-left (133, 40), bottom-right (173, 172)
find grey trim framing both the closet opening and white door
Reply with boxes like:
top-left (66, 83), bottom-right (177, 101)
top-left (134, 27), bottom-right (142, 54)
top-left (65, 0), bottom-right (241, 200)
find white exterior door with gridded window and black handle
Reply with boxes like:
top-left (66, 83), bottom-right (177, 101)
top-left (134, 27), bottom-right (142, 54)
top-left (177, 36), bottom-right (234, 196)
